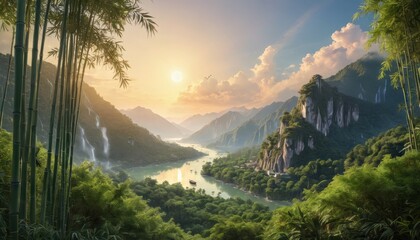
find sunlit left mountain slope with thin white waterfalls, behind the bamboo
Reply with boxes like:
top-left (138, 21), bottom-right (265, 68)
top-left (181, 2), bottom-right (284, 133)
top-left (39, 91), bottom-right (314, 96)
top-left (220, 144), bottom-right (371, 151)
top-left (0, 54), bottom-right (201, 166)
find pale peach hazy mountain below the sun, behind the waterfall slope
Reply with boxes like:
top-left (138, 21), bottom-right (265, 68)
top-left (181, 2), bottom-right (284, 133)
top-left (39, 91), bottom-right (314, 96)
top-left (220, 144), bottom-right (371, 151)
top-left (121, 106), bottom-right (191, 138)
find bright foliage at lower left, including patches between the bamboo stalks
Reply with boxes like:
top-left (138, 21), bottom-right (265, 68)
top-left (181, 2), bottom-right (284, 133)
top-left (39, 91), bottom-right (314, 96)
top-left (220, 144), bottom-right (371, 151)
top-left (0, 129), bottom-right (193, 239)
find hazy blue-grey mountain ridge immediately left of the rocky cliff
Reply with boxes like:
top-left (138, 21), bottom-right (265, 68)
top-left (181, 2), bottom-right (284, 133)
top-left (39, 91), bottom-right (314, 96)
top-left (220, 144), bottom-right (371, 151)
top-left (209, 97), bottom-right (297, 151)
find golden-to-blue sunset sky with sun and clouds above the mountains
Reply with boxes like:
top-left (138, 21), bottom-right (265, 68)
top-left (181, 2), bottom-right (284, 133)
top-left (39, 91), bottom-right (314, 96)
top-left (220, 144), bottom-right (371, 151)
top-left (0, 0), bottom-right (370, 122)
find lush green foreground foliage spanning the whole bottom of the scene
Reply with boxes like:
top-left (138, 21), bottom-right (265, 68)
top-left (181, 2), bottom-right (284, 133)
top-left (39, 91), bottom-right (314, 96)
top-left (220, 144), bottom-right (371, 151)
top-left (0, 124), bottom-right (420, 239)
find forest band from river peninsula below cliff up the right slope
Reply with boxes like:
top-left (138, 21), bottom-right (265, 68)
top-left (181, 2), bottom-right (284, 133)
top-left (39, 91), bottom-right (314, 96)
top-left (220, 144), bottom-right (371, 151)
top-left (202, 126), bottom-right (408, 200)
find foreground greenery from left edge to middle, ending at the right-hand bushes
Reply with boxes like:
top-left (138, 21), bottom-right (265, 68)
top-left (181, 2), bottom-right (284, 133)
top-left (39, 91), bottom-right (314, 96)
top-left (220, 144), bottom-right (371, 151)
top-left (0, 130), bottom-right (271, 239)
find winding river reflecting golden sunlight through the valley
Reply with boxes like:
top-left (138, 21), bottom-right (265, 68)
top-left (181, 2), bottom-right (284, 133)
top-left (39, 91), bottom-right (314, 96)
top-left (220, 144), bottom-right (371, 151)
top-left (127, 144), bottom-right (289, 210)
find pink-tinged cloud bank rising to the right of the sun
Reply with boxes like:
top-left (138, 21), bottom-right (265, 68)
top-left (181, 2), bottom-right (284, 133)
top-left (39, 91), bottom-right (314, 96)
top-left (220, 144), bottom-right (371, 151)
top-left (178, 23), bottom-right (374, 107)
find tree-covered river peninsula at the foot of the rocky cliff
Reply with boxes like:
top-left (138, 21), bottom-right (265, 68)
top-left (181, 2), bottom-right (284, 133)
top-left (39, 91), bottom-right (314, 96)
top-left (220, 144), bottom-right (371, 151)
top-left (202, 149), bottom-right (344, 200)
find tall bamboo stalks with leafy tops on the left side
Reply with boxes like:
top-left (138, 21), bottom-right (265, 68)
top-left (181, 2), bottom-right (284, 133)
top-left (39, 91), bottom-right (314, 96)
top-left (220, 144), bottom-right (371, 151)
top-left (0, 0), bottom-right (156, 239)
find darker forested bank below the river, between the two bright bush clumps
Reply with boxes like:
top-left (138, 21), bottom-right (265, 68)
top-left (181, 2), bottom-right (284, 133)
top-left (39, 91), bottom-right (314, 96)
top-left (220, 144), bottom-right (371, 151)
top-left (131, 178), bottom-right (271, 239)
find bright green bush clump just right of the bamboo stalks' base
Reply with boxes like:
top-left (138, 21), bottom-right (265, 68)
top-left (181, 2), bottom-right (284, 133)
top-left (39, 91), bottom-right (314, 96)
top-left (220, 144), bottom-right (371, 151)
top-left (69, 162), bottom-right (186, 239)
